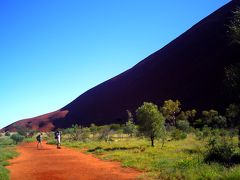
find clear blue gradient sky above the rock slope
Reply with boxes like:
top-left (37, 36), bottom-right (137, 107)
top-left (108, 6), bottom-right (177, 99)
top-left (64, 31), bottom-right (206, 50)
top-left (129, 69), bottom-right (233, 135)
top-left (0, 0), bottom-right (232, 128)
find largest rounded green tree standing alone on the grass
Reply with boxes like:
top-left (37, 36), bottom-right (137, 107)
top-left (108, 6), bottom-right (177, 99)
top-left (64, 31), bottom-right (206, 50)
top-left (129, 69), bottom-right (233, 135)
top-left (136, 102), bottom-right (166, 146)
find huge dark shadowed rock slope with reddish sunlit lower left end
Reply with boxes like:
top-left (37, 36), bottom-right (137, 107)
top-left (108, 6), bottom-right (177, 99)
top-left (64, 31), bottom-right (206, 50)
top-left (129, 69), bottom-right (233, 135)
top-left (4, 0), bottom-right (240, 130)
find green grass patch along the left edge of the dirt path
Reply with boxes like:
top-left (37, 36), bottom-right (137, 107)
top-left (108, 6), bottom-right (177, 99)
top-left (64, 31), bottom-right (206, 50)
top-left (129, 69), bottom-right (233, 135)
top-left (0, 137), bottom-right (18, 180)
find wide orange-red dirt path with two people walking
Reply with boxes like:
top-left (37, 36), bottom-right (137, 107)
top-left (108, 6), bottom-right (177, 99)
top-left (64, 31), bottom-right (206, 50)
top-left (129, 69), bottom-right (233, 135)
top-left (8, 143), bottom-right (140, 180)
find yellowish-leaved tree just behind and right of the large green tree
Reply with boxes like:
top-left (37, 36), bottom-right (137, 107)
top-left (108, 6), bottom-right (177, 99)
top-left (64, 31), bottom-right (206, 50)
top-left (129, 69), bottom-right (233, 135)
top-left (160, 99), bottom-right (181, 126)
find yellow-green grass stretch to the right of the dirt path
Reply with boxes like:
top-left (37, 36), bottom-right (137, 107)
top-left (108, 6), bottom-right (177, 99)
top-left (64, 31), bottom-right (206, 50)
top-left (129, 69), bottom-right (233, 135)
top-left (56, 135), bottom-right (240, 179)
